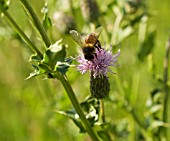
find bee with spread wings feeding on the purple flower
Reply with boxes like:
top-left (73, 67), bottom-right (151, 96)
top-left (70, 27), bottom-right (102, 61)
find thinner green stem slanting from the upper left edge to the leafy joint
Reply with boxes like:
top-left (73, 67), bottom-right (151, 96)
top-left (2, 10), bottom-right (43, 58)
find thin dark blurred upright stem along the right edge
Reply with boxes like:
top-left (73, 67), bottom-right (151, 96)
top-left (163, 37), bottom-right (170, 138)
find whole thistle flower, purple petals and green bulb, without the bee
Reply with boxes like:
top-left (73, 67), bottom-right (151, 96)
top-left (77, 49), bottom-right (120, 99)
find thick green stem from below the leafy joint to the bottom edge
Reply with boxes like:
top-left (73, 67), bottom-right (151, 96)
top-left (59, 75), bottom-right (99, 141)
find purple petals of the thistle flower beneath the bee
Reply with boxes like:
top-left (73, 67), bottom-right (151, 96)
top-left (77, 48), bottom-right (120, 78)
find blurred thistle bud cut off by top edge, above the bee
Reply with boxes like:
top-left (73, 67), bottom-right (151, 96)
top-left (80, 0), bottom-right (100, 22)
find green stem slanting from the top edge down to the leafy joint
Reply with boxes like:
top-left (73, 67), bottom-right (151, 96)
top-left (20, 0), bottom-right (51, 48)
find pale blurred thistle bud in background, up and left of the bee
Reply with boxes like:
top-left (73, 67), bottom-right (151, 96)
top-left (53, 12), bottom-right (76, 34)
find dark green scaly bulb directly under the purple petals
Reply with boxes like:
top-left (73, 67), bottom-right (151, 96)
top-left (90, 73), bottom-right (110, 99)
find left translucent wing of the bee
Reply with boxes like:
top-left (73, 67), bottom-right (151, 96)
top-left (70, 30), bottom-right (83, 48)
